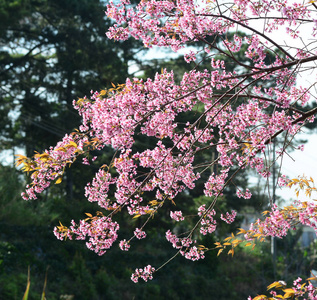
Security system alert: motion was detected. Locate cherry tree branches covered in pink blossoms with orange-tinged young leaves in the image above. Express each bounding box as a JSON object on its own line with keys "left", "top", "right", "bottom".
{"left": 17, "top": 0, "right": 317, "bottom": 299}
